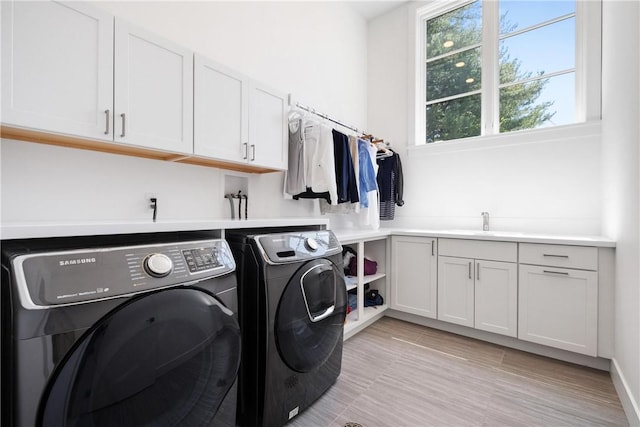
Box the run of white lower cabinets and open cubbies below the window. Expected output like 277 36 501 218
350 235 614 358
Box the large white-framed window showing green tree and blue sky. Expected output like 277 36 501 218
416 0 600 144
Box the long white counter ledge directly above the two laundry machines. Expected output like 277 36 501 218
0 218 329 240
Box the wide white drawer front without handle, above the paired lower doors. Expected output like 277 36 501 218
438 239 518 262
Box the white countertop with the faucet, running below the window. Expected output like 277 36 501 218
333 228 616 247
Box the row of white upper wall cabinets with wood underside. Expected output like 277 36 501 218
0 0 288 172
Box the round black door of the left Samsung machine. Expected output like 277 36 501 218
38 288 240 427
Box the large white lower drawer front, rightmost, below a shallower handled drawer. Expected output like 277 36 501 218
518 264 598 356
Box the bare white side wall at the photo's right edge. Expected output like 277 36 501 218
602 0 640 425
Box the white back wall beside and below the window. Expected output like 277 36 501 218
368 4 602 234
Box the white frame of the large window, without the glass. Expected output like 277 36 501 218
409 0 602 149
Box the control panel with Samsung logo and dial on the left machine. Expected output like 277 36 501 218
12 239 236 309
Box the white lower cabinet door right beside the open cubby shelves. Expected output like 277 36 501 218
391 236 438 319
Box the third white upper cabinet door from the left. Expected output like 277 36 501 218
193 55 249 162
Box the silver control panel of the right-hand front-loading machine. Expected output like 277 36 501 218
255 230 342 264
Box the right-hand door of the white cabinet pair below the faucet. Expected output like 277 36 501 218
474 260 518 337
